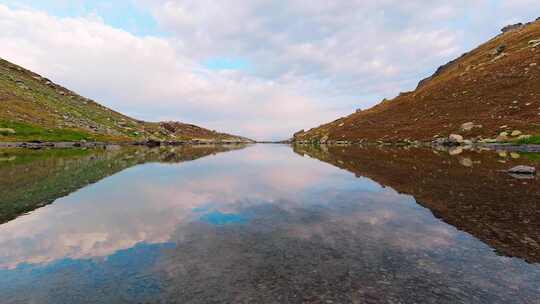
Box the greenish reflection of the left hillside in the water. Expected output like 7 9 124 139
0 145 245 223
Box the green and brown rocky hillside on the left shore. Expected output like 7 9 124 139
0 59 249 142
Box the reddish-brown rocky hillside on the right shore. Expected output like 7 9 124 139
294 20 540 143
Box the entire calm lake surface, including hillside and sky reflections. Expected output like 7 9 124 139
0 145 540 304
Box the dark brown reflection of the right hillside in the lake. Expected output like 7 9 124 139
294 146 540 263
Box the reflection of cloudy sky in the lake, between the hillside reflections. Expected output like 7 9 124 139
0 145 540 303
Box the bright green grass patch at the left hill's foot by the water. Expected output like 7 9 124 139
0 121 95 142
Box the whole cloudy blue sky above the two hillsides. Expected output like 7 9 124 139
0 0 540 140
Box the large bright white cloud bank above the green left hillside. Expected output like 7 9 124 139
0 6 346 138
